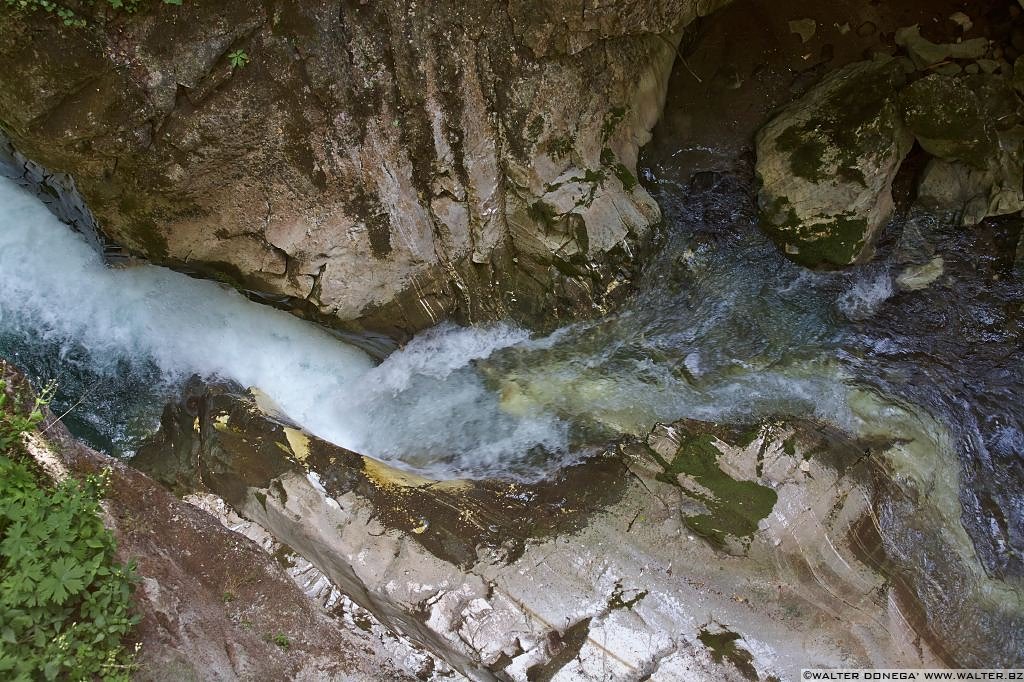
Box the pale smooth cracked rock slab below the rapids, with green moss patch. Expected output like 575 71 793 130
136 385 1018 680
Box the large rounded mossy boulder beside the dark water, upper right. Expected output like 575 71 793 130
756 58 912 267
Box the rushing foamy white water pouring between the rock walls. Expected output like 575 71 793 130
0 179 567 475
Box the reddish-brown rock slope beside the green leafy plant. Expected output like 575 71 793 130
0 360 432 682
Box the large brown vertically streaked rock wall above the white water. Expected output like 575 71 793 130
0 0 726 337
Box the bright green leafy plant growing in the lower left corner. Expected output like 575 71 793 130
0 380 137 680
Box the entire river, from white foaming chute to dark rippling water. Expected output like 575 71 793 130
0 139 1024 663
